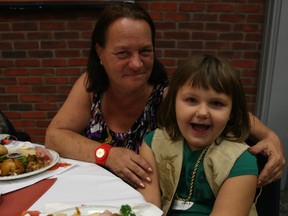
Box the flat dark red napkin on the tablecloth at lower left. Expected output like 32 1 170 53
0 178 57 216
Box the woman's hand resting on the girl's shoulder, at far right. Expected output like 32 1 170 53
249 133 285 187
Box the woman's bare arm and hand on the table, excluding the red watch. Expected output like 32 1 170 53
45 73 151 187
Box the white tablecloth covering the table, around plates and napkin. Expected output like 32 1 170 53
0 141 162 216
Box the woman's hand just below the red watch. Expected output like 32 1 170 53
105 147 152 188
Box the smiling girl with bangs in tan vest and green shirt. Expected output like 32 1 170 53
139 55 258 216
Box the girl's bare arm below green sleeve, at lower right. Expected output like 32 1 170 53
211 175 257 216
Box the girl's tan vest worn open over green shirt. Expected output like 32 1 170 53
151 129 257 216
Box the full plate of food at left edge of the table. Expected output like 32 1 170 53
0 145 60 181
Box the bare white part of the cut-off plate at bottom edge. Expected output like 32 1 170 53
53 205 120 216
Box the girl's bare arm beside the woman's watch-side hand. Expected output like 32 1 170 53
138 141 161 208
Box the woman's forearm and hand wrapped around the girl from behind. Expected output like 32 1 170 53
249 114 285 186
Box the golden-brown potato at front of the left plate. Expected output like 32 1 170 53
1 158 25 176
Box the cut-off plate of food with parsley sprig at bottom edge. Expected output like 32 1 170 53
52 205 136 216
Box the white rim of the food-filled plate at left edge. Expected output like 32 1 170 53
0 149 60 181
